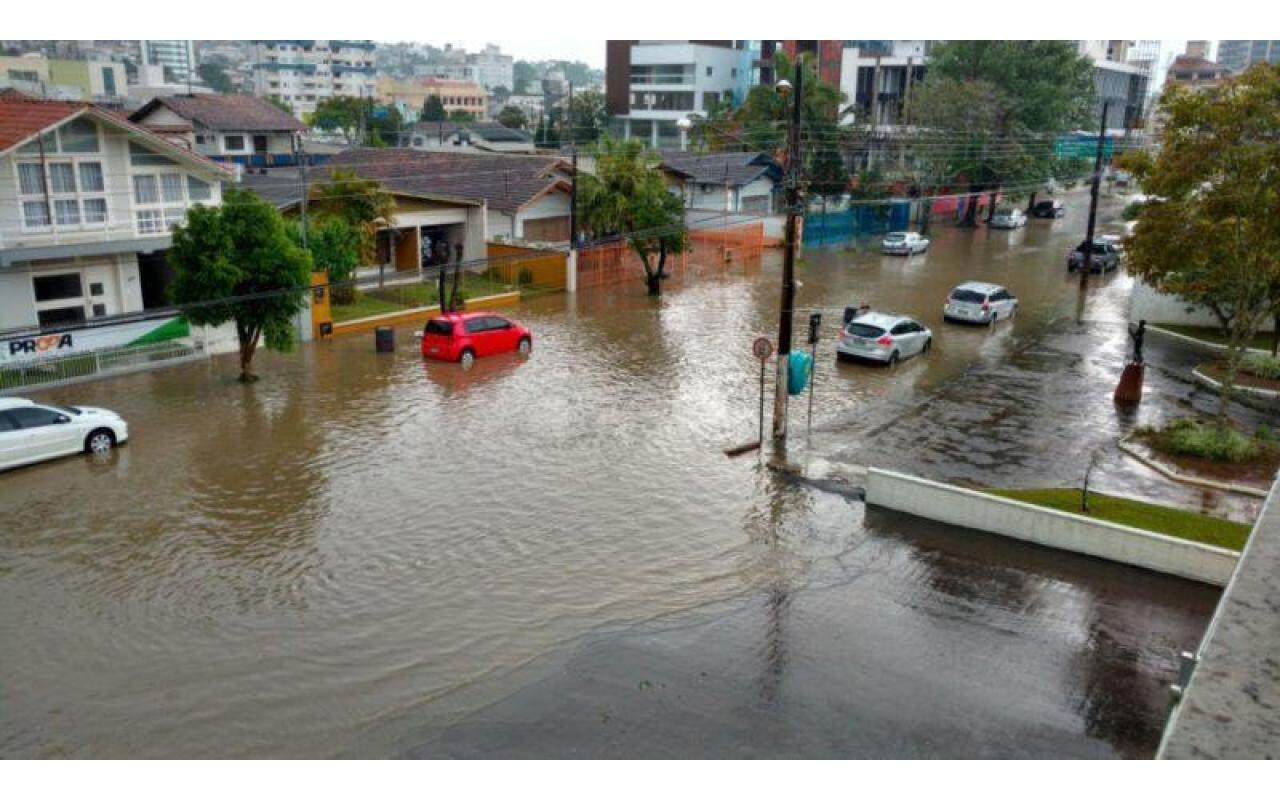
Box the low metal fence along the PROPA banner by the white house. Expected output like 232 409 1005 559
0 340 205 394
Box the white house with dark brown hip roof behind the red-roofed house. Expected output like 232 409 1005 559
129 93 307 166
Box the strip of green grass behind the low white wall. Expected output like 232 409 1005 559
987 489 1251 550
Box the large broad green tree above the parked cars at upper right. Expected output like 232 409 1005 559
911 40 1094 227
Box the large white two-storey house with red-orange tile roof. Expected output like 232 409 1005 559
0 91 234 350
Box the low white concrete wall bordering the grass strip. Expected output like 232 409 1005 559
867 468 1239 586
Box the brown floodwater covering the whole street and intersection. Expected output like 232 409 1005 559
0 193 1218 758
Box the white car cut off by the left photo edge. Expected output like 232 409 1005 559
0 397 129 470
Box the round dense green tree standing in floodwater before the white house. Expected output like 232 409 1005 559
168 187 311 383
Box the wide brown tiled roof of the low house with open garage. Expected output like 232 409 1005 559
329 147 571 214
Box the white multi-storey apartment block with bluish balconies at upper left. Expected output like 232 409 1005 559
253 38 376 119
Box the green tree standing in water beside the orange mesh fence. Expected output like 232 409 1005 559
577 137 689 296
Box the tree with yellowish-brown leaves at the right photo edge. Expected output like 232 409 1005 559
1123 64 1280 429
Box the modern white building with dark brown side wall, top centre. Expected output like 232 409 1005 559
604 40 754 147
